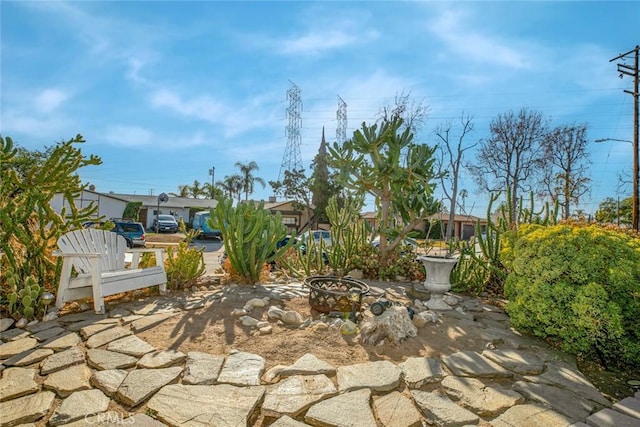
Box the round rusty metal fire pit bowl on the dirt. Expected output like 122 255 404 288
304 276 369 314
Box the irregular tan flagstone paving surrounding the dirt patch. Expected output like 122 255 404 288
0 282 640 427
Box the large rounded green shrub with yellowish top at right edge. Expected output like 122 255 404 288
504 224 640 366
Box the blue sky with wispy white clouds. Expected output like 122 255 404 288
0 0 640 216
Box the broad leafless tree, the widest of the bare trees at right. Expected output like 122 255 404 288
467 108 548 224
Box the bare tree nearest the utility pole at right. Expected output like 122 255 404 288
541 124 591 219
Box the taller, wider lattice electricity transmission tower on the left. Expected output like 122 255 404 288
278 80 302 181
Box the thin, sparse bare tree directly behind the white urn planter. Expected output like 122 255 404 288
436 114 478 240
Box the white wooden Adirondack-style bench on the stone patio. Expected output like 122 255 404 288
54 228 167 314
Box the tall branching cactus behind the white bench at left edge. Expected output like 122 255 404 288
0 135 101 298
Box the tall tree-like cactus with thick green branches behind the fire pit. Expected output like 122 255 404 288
329 115 439 265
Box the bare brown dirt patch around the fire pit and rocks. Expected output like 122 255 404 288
139 286 484 369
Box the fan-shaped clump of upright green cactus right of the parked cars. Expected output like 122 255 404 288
208 199 294 284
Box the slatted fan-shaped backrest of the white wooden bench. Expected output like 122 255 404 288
58 228 127 273
